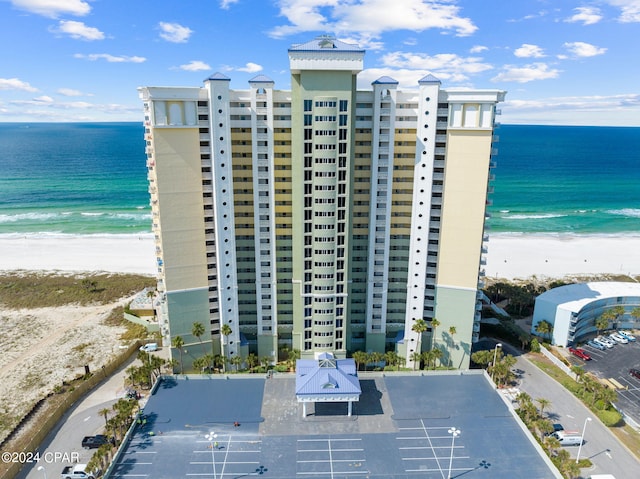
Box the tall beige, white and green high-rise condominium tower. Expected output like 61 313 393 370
140 36 505 367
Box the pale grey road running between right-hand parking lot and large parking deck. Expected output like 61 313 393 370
504 345 640 479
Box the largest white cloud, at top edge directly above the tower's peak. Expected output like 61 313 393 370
271 0 478 37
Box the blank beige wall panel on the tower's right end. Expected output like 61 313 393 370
438 130 492 289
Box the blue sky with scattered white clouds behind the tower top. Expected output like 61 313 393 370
0 0 640 126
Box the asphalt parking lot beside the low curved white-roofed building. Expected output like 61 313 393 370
569 335 640 424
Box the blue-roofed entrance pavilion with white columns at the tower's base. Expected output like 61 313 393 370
296 353 362 417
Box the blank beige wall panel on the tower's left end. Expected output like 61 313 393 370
153 128 207 291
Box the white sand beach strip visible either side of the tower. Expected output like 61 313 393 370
0 233 640 279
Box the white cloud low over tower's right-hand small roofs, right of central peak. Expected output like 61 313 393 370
382 52 493 82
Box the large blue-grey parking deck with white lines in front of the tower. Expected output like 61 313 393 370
109 372 554 479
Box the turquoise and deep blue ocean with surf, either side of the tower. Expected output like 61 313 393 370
0 123 640 237
